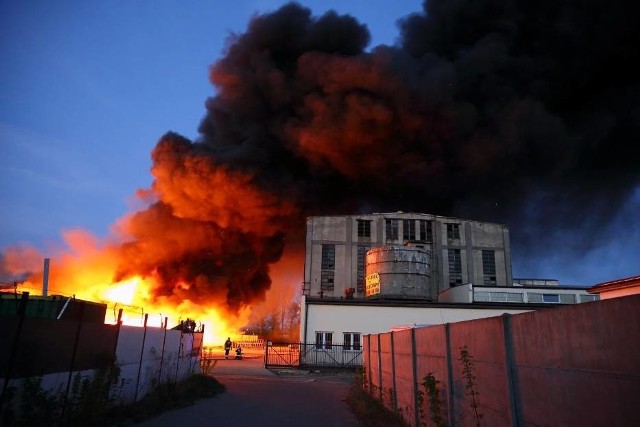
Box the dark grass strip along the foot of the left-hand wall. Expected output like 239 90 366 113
107 374 225 426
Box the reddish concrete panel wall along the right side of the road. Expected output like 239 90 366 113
363 296 640 426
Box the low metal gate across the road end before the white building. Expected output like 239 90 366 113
264 342 362 368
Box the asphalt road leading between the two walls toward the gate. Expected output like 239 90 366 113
139 355 361 427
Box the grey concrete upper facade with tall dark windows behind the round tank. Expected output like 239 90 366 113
303 212 513 299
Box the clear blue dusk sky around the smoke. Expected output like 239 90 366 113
0 0 640 285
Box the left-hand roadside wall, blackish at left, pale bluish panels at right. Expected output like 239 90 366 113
0 317 203 416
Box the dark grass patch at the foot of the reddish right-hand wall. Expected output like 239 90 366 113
346 375 407 427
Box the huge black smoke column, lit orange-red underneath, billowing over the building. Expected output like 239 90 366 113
2 0 640 310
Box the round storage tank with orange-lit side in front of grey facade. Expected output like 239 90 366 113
365 246 437 301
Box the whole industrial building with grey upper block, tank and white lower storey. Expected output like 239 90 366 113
300 212 598 363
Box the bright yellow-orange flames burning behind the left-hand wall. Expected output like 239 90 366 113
7 230 250 346
